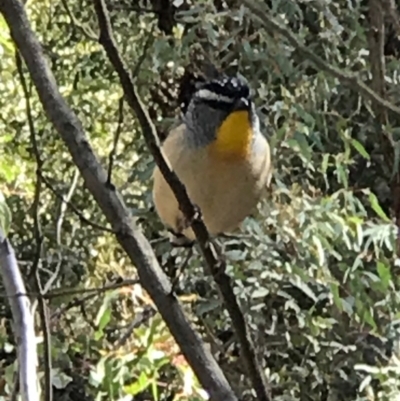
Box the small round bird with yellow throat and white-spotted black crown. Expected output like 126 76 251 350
153 71 272 243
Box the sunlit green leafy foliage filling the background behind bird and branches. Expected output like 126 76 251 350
0 0 400 401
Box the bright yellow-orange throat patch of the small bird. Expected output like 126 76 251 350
209 110 253 160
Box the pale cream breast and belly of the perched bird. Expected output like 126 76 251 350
153 125 271 239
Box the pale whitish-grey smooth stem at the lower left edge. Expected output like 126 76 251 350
0 229 39 401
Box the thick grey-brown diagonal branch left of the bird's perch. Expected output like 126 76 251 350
0 0 237 401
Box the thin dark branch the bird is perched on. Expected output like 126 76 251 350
94 0 270 401
